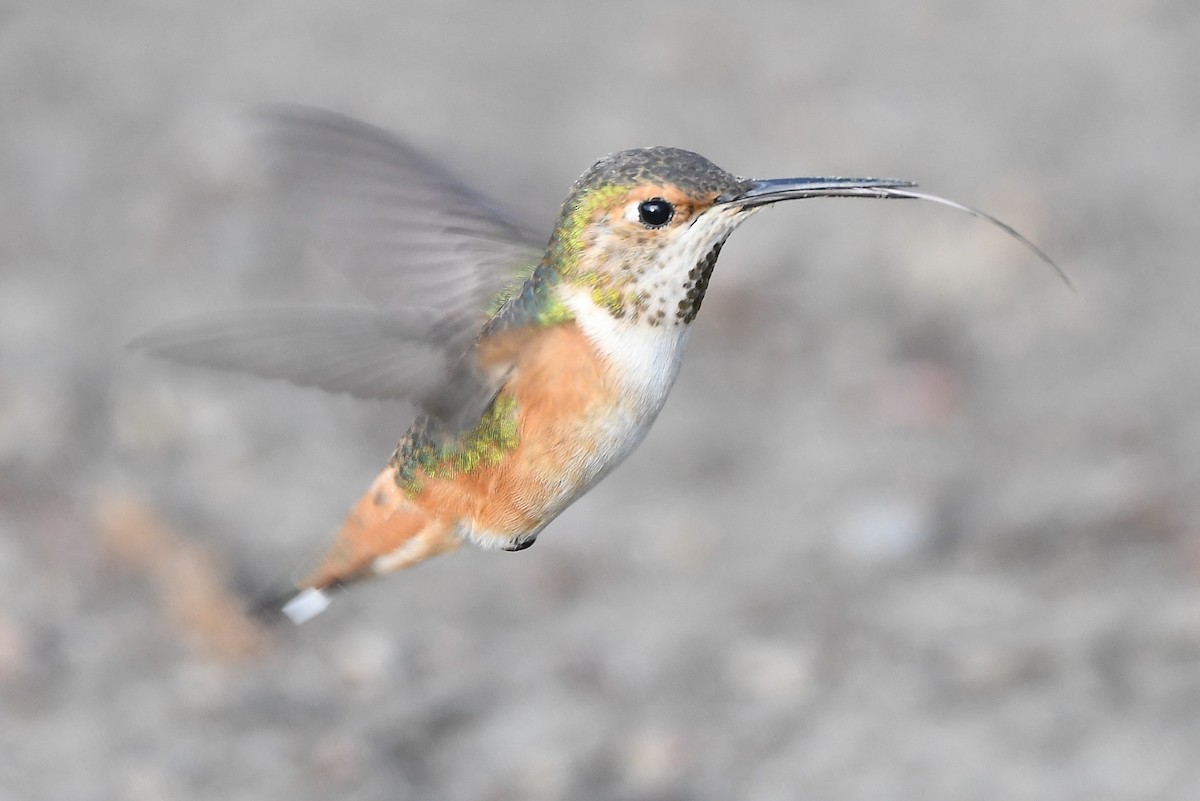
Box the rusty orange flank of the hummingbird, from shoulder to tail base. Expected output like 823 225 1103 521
300 323 618 589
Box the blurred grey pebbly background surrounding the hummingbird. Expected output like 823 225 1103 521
0 0 1200 801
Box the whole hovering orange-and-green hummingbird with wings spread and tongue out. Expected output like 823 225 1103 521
133 108 1066 622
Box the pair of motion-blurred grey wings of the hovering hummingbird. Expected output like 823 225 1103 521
131 107 545 435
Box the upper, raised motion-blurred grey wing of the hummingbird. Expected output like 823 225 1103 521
263 107 546 345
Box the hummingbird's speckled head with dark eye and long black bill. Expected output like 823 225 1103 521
546 147 912 326
